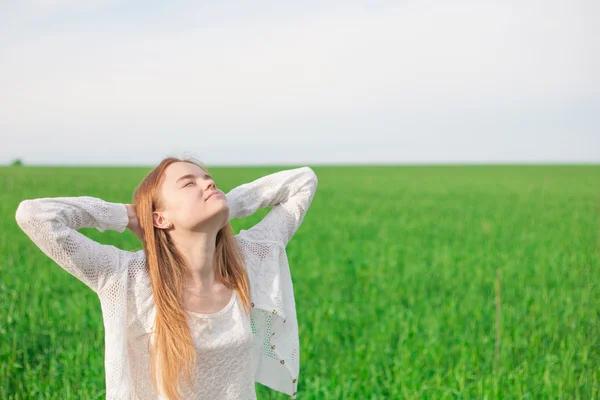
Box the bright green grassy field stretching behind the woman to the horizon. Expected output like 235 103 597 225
0 166 600 399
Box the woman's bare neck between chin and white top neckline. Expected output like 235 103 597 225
171 230 217 291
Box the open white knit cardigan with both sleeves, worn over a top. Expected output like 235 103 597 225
16 167 318 400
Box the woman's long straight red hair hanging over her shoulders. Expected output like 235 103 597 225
133 157 251 400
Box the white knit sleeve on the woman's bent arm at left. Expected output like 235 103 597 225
16 196 129 293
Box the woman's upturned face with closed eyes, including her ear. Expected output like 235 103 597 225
153 162 229 230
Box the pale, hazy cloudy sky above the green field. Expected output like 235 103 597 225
0 0 600 166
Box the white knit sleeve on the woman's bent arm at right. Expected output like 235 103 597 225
226 167 318 247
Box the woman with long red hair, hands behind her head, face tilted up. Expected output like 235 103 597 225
16 157 318 400
